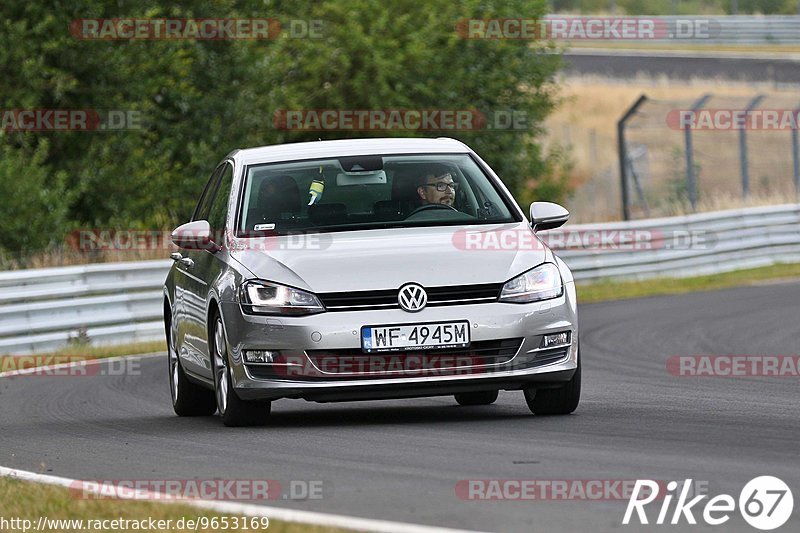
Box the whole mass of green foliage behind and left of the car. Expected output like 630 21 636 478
0 0 566 258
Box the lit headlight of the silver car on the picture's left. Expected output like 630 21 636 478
241 281 325 315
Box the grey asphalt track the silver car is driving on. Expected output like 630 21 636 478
0 283 800 532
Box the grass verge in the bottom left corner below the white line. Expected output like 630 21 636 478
0 478 347 533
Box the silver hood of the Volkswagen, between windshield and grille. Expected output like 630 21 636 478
231 222 548 292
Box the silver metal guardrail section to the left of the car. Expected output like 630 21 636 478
0 260 172 354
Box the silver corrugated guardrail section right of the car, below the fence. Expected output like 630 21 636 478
547 204 800 281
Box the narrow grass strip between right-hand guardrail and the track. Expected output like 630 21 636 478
577 263 800 303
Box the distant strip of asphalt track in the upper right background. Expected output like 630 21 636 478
564 49 800 85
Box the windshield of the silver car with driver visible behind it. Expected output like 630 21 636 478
238 154 516 237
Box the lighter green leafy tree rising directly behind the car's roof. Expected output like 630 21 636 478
259 0 564 204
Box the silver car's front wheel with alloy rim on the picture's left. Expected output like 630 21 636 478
209 314 272 427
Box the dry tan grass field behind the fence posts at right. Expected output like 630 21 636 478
546 77 800 222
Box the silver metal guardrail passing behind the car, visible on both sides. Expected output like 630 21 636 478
0 204 800 354
